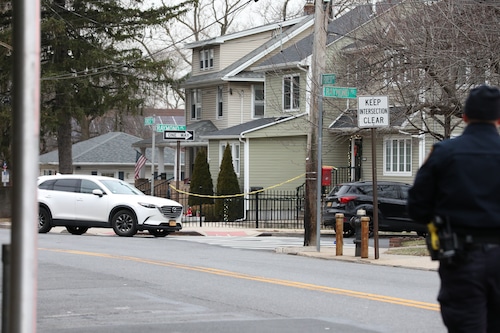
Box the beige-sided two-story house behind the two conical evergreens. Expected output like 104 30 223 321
184 15 314 191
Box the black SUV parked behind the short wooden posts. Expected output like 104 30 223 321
323 181 427 237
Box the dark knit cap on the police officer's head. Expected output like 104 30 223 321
464 85 500 121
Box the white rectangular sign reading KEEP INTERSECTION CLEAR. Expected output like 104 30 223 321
358 96 389 128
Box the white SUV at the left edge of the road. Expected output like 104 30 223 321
38 175 182 237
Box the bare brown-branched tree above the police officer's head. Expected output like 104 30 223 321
340 0 500 140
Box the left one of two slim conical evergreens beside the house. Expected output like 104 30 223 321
188 149 214 206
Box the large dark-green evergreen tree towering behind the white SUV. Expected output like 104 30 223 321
19 0 188 173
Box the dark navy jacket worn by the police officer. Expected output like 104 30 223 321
408 123 500 231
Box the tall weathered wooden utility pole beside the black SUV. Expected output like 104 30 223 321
304 0 330 246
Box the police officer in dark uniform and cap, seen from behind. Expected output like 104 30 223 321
408 85 500 333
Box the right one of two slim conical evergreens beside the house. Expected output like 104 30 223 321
215 144 243 221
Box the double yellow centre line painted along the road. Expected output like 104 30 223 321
39 248 440 311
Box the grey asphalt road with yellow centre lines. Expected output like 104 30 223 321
0 230 445 333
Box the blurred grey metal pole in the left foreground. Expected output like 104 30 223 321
10 0 41 333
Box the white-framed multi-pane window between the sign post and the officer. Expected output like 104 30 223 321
384 138 412 176
